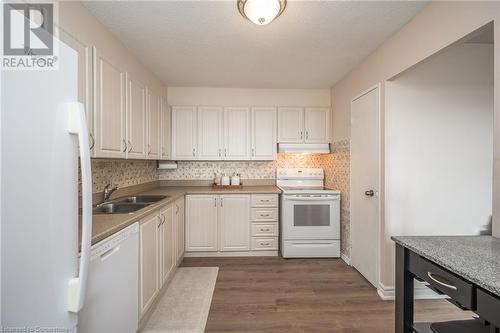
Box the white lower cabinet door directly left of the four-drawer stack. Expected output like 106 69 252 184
219 194 250 251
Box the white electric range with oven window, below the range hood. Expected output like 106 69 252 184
276 168 340 258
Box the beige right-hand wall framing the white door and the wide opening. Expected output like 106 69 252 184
332 2 500 287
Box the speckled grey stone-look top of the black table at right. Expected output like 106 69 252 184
392 236 500 296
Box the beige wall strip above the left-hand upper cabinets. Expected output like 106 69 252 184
58 1 165 92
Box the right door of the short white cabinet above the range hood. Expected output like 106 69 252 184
304 108 331 143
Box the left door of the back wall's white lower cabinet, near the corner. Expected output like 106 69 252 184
186 195 219 251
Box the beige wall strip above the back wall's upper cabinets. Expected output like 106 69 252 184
168 87 331 107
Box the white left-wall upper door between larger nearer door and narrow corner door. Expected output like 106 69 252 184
127 74 146 159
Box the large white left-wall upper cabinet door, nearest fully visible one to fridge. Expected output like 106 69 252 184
94 48 127 158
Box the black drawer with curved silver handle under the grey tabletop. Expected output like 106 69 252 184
408 252 476 310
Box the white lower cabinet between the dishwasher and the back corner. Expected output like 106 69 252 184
139 197 184 320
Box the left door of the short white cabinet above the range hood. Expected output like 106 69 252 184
278 107 304 143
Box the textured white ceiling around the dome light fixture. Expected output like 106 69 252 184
85 0 427 88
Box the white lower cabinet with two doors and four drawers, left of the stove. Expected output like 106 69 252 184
186 194 279 257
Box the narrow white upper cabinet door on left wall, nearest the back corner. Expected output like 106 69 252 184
146 90 161 160
